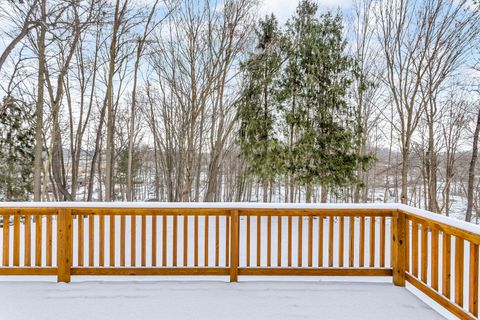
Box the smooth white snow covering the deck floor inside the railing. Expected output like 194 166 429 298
0 280 445 320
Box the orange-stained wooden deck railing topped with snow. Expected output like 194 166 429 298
0 203 480 319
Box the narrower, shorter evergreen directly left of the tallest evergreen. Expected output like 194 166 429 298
238 15 281 201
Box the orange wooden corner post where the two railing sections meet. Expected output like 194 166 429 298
392 210 407 287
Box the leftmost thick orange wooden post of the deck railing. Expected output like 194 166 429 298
57 208 72 282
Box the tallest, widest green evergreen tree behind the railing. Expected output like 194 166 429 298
281 0 368 201
